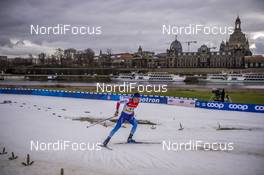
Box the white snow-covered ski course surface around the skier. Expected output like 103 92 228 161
0 94 264 175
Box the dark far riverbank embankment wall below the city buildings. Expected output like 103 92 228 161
6 66 264 75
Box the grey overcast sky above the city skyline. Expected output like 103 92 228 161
0 0 264 57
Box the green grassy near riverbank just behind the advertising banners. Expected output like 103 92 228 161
0 85 264 104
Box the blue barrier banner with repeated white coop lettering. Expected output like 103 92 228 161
195 100 264 113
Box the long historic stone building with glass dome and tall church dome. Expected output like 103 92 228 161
167 17 252 68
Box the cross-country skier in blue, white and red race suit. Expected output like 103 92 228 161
103 93 140 146
